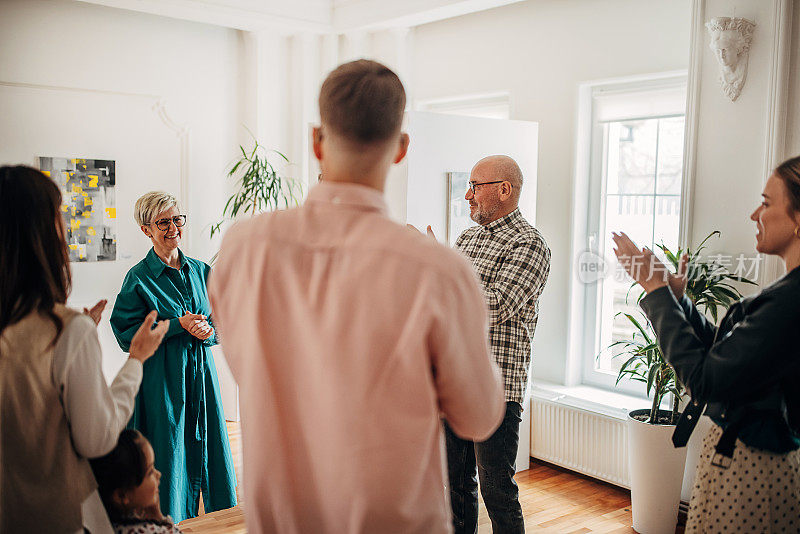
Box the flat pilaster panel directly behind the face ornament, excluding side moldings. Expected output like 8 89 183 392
691 0 774 268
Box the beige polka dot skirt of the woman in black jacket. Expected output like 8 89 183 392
686 425 800 534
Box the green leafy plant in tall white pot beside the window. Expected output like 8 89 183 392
609 232 755 534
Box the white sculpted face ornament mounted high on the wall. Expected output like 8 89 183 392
706 17 756 102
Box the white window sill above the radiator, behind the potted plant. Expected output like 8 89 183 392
531 380 650 421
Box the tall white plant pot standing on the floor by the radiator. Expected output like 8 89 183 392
628 409 686 534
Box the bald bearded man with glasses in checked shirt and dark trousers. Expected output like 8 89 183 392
445 156 550 534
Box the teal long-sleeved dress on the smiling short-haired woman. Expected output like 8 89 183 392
111 249 236 522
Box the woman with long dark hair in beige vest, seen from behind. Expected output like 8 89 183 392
0 166 169 533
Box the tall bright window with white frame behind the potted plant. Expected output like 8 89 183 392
573 75 686 395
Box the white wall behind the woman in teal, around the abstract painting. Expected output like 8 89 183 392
0 0 246 404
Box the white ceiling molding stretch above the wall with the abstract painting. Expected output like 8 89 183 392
78 0 332 34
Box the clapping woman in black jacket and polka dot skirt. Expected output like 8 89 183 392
613 157 800 533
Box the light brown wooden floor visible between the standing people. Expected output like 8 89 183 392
180 422 635 534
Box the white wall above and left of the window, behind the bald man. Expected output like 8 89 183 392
409 0 690 383
